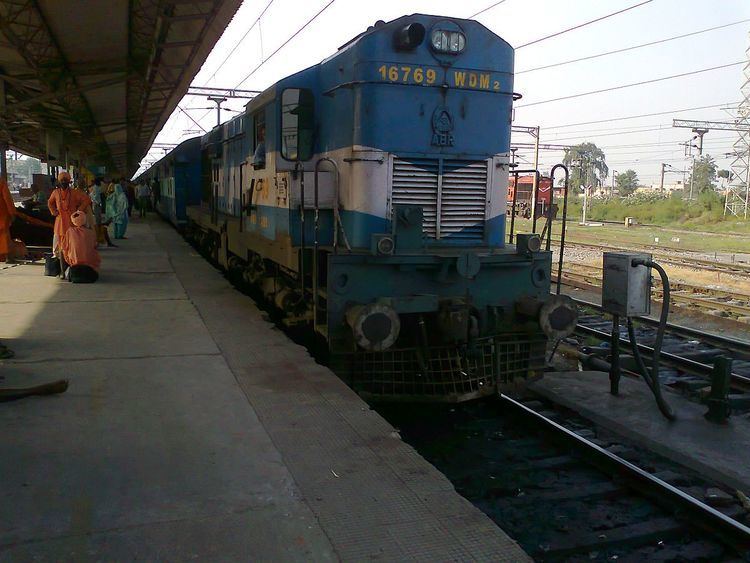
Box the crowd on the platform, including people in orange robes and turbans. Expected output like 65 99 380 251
0 171 152 283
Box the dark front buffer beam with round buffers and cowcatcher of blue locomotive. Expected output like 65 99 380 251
326 240 575 402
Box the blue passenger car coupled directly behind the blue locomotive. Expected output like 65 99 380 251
136 137 201 228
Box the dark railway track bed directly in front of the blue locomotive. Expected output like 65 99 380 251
383 396 750 561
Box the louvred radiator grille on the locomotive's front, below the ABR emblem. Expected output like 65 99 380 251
391 157 487 241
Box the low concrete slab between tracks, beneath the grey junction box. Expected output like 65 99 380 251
530 371 750 493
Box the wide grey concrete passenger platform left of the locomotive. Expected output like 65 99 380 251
0 220 528 561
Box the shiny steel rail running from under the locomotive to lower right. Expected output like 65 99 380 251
500 394 750 555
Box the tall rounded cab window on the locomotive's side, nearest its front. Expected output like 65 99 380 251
281 88 315 160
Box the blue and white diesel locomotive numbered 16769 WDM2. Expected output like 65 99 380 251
140 14 575 401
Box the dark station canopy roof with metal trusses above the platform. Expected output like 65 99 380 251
0 0 241 177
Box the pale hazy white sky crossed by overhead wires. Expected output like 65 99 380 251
137 0 750 185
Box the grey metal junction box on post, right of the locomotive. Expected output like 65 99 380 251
602 252 651 317
